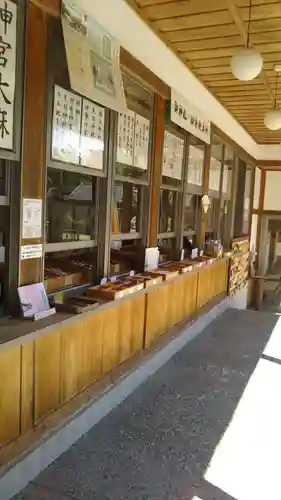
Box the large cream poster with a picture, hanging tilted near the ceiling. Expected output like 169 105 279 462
61 0 126 112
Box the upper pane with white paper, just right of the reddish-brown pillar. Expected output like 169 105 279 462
162 130 184 185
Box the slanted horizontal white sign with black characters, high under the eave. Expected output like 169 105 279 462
171 89 211 144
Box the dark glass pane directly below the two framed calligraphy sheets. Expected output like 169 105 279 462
46 168 97 243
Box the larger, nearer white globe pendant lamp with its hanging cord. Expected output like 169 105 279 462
230 0 263 82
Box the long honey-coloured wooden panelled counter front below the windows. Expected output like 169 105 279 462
0 259 228 458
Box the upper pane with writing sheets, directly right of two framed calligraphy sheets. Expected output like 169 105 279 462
116 75 152 180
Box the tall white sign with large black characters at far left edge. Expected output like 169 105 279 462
0 0 17 150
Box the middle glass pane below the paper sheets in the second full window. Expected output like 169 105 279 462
112 181 141 233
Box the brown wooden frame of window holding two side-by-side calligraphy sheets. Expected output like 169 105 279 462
43 19 110 282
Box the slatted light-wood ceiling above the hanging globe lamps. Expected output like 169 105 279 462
127 0 281 144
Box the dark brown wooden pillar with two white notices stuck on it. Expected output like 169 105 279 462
20 2 48 285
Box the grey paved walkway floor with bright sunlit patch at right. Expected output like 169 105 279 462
14 310 281 500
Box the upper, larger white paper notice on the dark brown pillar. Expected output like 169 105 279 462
22 198 42 240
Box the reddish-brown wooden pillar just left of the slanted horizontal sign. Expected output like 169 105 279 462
148 94 165 247
